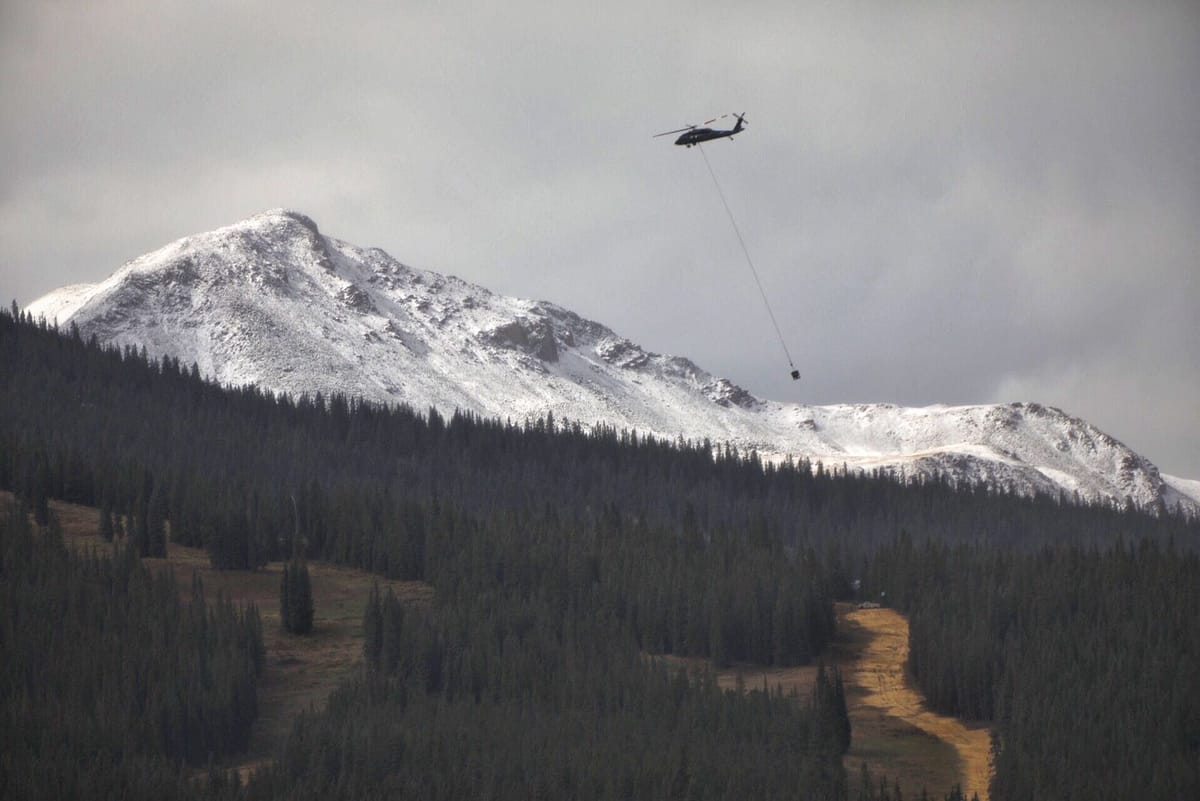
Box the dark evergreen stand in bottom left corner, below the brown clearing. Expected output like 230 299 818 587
0 507 263 800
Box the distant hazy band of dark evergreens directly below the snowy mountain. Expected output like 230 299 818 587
0 303 1198 578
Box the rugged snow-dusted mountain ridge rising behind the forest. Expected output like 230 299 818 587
26 210 1200 512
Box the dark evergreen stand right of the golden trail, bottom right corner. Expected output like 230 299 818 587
869 537 1200 801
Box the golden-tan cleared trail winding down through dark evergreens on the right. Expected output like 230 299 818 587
842 609 991 801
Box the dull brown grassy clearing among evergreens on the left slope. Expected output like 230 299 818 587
21 493 433 775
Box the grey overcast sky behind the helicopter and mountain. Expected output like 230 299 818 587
0 0 1200 478
